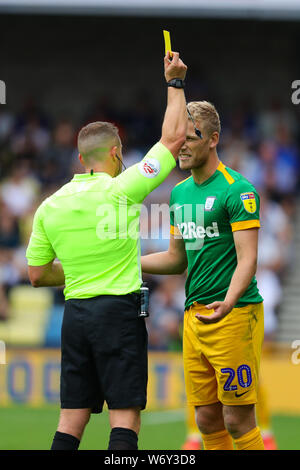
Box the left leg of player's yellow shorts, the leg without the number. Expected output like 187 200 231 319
183 309 218 406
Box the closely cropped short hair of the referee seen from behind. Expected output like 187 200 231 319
77 121 121 160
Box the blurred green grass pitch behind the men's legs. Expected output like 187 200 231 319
0 405 300 450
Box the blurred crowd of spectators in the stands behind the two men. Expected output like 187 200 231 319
0 93 300 350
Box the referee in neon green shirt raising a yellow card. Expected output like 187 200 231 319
26 52 187 450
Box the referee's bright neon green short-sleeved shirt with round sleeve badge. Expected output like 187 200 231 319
26 142 176 300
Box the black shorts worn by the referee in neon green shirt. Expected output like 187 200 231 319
60 293 148 413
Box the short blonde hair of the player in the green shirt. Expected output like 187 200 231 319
187 101 221 135
